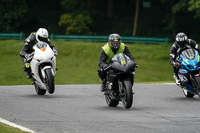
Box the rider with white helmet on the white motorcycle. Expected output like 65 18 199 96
20 28 58 79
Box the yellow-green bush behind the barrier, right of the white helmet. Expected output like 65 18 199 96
59 13 92 35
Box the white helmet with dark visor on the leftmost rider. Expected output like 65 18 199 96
36 28 49 42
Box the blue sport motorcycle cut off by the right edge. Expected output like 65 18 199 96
178 49 200 98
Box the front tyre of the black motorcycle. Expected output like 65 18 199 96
122 80 133 109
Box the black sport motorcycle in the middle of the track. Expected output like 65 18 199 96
104 53 138 109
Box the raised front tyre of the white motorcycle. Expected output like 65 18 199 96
45 69 55 94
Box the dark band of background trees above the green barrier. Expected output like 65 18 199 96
0 0 200 39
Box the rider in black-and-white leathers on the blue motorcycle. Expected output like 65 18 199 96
170 32 200 87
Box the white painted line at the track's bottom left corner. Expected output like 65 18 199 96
0 118 36 133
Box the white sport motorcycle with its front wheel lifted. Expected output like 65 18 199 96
28 43 56 95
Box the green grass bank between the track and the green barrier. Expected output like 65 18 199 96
0 40 173 85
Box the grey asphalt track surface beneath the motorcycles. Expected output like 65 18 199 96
0 84 200 133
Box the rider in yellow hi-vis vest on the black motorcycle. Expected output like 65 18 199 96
97 33 134 92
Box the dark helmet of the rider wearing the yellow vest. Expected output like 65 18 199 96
108 34 121 50
